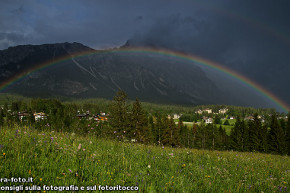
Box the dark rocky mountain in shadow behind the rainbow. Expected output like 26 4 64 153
0 43 265 106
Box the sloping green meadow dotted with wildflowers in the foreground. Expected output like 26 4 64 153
0 128 290 192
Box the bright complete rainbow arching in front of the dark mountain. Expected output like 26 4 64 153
0 47 290 112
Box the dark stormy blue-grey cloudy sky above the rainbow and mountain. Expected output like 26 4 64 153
0 0 290 108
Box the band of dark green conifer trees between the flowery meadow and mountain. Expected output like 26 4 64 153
0 90 290 155
